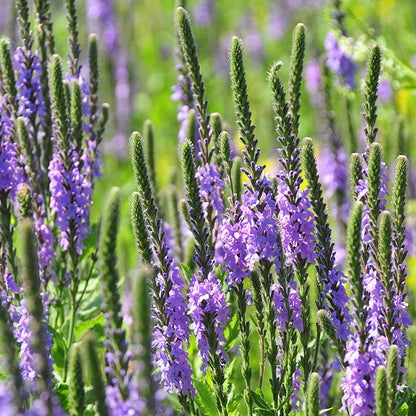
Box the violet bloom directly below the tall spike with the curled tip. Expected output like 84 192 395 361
277 181 315 265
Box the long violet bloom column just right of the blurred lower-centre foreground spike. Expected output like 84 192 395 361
152 259 195 396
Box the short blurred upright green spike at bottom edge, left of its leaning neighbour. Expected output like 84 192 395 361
69 344 85 416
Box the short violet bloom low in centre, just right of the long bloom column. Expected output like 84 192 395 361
188 271 229 373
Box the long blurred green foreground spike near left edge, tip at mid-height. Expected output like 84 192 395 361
18 218 56 414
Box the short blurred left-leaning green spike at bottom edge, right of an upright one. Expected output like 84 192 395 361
82 333 109 416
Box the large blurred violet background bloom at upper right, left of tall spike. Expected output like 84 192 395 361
325 31 358 89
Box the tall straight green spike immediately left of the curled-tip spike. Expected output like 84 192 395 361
229 37 262 189
